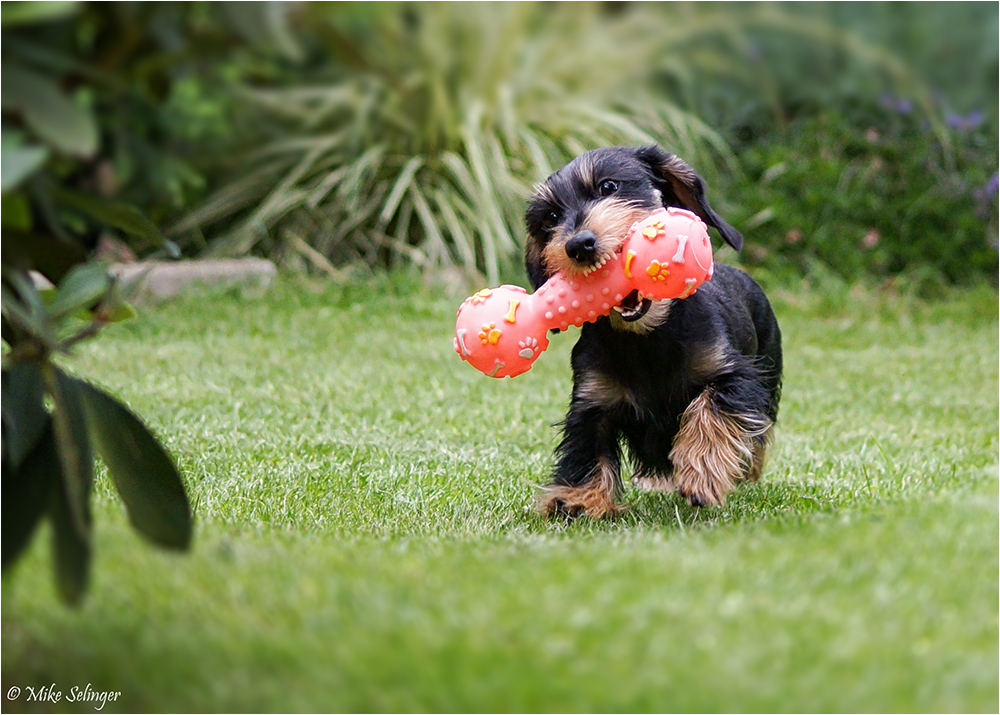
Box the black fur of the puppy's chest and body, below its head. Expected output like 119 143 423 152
554 264 781 485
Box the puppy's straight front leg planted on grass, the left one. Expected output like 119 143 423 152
538 398 621 519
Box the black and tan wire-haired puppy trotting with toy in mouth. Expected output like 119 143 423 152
525 146 782 518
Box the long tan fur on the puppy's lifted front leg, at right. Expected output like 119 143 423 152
670 388 771 506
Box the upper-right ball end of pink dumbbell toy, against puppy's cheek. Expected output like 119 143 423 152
624 207 714 300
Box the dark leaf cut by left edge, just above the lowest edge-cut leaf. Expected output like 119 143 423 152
0 360 49 474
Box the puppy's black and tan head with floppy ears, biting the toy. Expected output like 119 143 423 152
525 146 743 330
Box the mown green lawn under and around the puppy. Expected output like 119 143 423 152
3 272 998 712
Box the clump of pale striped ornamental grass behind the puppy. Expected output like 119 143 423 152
173 4 730 281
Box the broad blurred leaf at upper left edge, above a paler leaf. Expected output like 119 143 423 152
0 60 99 157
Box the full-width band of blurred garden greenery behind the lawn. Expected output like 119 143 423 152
4 2 997 290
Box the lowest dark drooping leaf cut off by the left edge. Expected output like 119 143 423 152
2 416 59 571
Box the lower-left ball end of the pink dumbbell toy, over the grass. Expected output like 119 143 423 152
453 286 549 377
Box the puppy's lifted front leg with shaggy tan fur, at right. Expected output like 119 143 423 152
670 372 772 506
